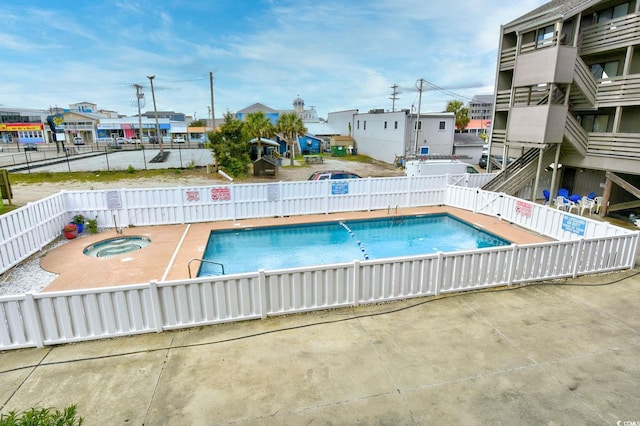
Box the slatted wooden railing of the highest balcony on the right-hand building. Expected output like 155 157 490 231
578 13 640 55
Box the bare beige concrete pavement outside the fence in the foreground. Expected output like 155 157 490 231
0 269 640 426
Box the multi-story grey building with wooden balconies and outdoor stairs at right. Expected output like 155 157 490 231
488 0 640 216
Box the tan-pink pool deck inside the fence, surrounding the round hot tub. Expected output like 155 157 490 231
40 207 549 291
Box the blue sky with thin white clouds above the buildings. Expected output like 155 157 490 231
0 0 546 118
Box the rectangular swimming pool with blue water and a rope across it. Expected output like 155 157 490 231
198 214 510 276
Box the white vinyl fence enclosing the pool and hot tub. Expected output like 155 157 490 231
0 175 639 350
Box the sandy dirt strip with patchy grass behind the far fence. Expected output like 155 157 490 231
11 157 404 206
